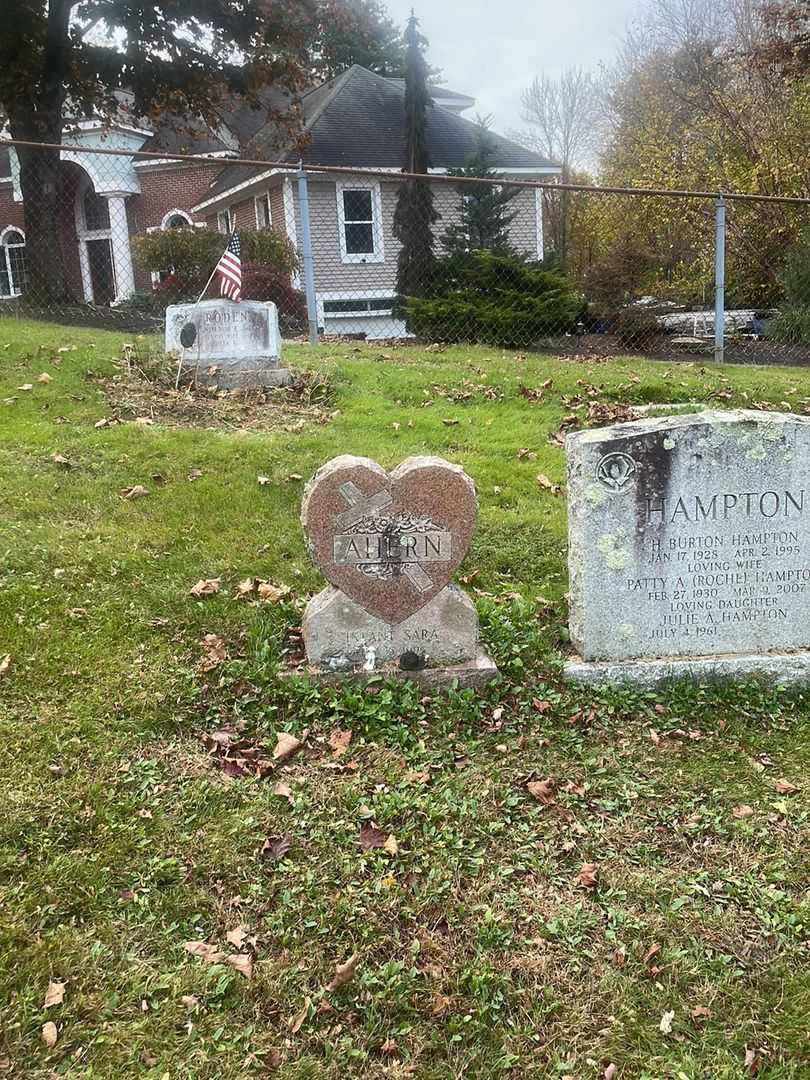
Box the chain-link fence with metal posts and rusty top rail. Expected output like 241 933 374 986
0 137 810 364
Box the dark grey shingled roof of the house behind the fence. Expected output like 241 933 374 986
201 64 558 199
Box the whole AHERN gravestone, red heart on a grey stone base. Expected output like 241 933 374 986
294 455 497 686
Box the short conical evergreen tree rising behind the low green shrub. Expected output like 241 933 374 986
442 118 517 256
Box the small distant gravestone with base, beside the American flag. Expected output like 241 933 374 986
165 299 292 390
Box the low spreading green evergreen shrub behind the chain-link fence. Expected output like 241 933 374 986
405 251 582 347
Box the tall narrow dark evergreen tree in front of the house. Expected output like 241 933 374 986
393 14 437 304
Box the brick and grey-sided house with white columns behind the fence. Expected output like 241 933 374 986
0 65 561 337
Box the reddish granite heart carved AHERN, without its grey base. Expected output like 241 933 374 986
301 455 478 624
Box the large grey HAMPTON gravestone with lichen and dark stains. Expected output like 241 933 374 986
566 411 810 686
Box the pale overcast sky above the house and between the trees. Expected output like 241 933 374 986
386 0 640 133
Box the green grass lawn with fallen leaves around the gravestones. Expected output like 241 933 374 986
0 320 810 1080
